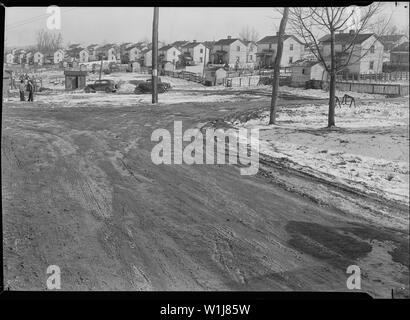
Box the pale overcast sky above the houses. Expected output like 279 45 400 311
5 2 409 47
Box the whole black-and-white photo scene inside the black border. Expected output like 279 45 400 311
1 2 410 302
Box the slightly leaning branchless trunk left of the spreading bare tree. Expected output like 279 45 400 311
269 7 289 124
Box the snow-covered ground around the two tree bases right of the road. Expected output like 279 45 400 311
233 101 409 204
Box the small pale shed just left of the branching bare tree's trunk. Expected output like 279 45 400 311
290 60 327 87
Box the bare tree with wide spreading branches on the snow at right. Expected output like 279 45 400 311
289 2 381 127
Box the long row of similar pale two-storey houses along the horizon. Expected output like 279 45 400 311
5 31 408 74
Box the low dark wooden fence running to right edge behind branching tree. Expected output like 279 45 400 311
336 81 409 96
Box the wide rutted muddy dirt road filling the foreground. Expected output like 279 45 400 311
2 95 409 297
